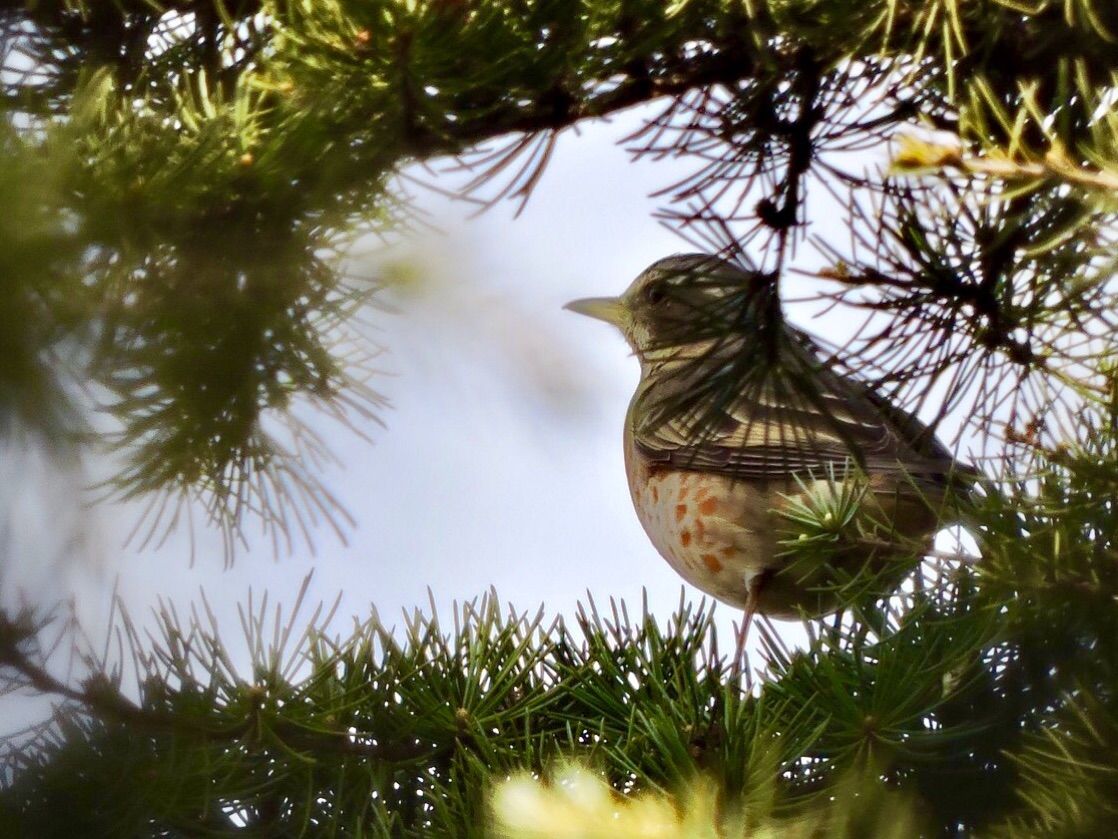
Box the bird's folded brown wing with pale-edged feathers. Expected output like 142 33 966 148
632 335 954 480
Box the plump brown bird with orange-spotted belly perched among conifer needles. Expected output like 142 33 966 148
566 254 964 625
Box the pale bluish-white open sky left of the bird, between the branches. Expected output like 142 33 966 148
0 105 903 698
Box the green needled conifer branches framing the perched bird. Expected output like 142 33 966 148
0 0 1118 837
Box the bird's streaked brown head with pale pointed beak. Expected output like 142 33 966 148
565 254 760 361
